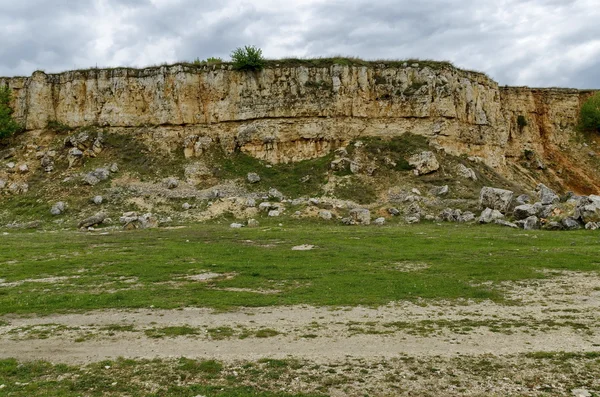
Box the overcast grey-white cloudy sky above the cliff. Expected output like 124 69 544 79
0 0 600 88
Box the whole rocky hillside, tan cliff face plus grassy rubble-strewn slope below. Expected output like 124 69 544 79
0 59 600 229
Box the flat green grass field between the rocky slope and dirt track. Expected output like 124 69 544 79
0 221 600 315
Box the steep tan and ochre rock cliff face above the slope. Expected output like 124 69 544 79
0 64 590 189
